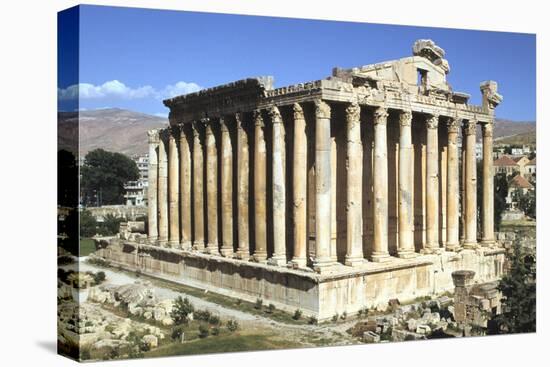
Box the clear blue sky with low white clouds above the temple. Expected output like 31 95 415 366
58 6 536 120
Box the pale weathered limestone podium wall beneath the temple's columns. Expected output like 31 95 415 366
96 244 504 320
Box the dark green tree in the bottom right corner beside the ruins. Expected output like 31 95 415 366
489 241 537 334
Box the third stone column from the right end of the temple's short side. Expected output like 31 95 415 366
445 118 460 251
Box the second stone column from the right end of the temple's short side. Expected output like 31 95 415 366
463 120 477 248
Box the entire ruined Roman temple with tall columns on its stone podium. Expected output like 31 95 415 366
99 40 504 320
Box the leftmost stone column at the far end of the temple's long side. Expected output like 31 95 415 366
147 130 159 244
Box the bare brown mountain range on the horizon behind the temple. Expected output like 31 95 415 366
58 108 536 156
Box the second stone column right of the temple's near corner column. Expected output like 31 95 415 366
372 107 390 262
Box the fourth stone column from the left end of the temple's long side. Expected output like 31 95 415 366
179 124 192 250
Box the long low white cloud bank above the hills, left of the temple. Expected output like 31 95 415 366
57 80 202 100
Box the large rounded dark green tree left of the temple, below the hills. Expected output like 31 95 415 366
81 149 139 205
